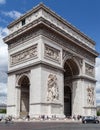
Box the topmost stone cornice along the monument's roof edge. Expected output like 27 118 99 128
8 4 95 45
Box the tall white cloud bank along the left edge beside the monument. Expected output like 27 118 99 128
0 27 8 103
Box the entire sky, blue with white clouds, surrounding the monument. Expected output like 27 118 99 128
0 0 100 104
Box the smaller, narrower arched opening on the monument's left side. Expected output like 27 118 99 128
19 75 30 116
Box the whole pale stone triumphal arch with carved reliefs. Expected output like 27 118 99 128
4 4 98 117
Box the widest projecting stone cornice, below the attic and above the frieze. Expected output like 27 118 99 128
4 17 98 57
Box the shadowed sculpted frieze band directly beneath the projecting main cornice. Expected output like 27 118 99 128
6 19 95 63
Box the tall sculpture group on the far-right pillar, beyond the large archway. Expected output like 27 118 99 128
87 86 94 106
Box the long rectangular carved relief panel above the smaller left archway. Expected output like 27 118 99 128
10 45 37 65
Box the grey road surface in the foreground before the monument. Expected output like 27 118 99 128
0 121 100 130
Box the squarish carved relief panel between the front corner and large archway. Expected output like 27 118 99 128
44 44 60 63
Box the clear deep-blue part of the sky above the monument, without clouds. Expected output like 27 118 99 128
0 0 100 52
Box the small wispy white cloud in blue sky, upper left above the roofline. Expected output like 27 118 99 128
2 10 22 19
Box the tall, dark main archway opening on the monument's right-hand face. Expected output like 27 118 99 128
64 59 79 116
